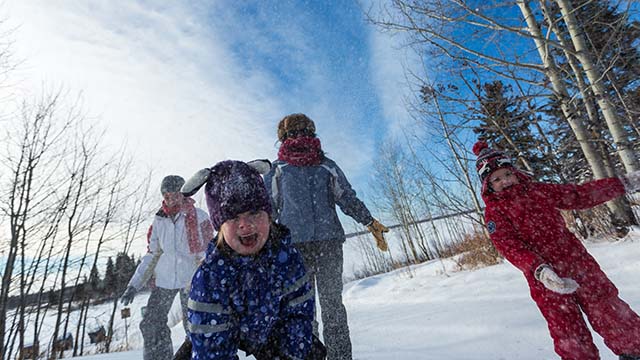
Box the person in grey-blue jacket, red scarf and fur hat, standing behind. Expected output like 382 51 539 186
265 114 388 360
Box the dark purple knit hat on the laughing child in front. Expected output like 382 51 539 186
205 160 271 230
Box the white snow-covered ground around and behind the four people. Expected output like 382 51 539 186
38 230 640 360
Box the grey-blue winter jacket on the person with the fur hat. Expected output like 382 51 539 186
265 157 373 243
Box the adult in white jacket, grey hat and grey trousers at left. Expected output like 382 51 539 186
121 175 213 360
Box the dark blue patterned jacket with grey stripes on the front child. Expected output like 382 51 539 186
188 224 315 360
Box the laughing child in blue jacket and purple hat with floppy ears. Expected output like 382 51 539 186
183 160 324 360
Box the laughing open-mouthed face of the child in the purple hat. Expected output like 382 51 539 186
220 210 271 255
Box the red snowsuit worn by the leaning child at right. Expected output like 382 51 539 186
482 170 640 360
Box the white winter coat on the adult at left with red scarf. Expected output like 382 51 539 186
129 208 213 289
